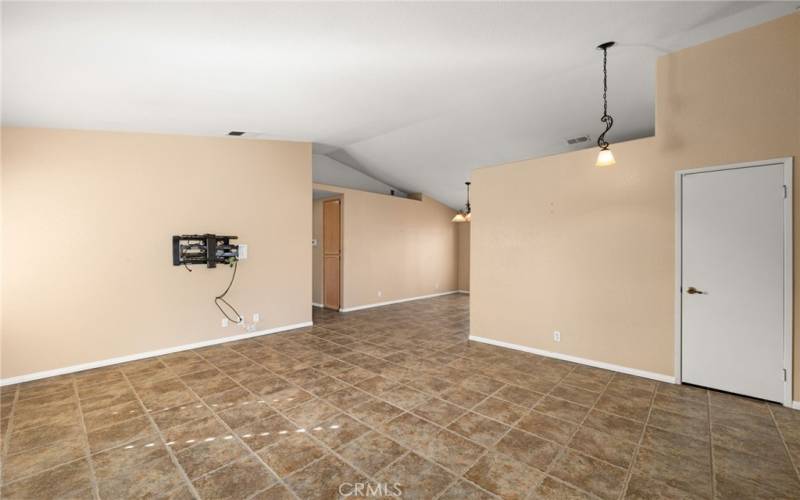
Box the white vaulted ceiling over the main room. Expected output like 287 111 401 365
2 2 798 207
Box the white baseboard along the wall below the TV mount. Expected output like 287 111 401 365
0 321 313 386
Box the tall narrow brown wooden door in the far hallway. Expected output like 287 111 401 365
322 200 342 310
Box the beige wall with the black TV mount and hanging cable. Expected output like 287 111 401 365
2 128 311 378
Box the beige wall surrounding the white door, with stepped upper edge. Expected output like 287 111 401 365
471 14 800 399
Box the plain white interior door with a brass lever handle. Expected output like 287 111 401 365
681 163 786 402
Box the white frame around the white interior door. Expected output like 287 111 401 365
674 157 794 407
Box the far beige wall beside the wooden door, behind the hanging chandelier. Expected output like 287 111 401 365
314 184 458 309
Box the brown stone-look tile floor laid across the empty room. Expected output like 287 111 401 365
0 295 800 499
